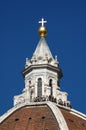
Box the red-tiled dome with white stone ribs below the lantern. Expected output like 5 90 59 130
0 101 86 130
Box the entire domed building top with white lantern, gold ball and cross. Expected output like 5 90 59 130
0 19 86 130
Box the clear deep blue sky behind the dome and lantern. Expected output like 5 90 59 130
0 0 86 115
